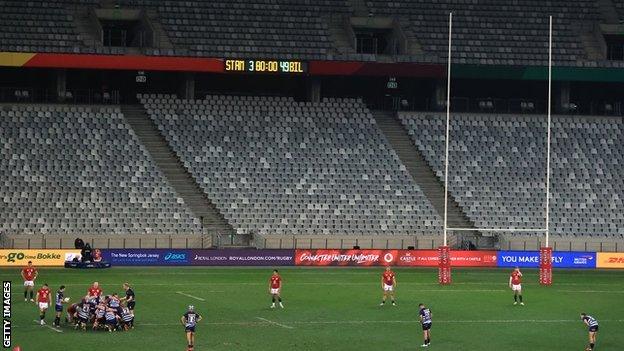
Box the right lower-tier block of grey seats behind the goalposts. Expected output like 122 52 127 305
400 112 624 237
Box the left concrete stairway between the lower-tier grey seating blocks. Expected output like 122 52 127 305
121 105 234 234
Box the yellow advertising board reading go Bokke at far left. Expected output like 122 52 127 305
0 249 80 267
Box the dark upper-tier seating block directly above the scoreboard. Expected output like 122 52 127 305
149 0 350 59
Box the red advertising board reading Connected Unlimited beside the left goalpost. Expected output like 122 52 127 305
295 250 497 267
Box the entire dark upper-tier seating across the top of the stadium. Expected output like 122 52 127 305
0 0 624 67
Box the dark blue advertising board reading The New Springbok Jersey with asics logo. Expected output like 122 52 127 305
102 249 191 266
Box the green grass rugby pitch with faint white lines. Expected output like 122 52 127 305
0 268 624 351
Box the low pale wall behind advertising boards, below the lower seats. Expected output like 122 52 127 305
0 234 624 252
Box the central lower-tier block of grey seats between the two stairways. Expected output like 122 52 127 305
139 94 441 235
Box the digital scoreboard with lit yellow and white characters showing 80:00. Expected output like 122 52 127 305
224 59 308 74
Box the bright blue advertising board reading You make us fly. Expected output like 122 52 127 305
497 251 596 268
